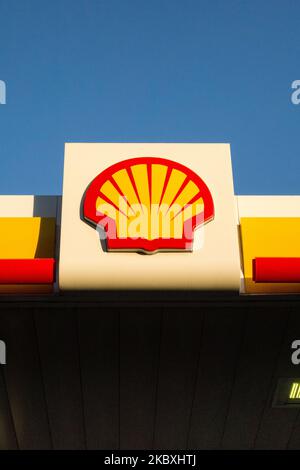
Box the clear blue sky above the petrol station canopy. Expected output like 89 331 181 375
0 0 300 194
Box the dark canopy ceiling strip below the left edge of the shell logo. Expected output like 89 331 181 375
78 303 119 449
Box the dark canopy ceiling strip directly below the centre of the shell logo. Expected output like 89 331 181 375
120 304 162 449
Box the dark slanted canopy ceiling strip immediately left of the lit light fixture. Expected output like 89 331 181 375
222 302 287 449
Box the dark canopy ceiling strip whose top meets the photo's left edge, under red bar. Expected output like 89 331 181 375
0 304 52 449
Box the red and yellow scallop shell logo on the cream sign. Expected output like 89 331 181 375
83 157 214 254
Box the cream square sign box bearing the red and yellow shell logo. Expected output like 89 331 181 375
59 143 240 291
